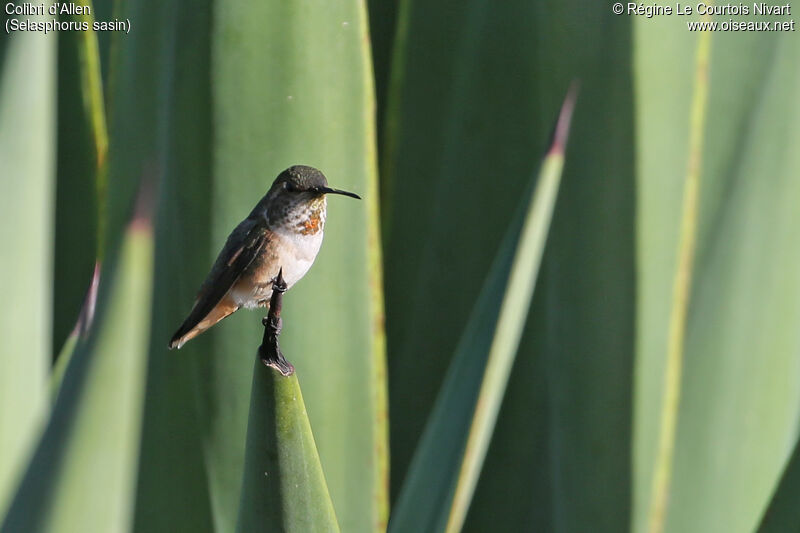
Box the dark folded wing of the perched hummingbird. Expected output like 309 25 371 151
170 218 268 347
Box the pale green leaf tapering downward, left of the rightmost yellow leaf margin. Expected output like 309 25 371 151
632 24 696 532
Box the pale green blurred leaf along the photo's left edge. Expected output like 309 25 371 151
0 26 57 518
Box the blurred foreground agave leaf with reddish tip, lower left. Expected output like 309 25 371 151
1 208 153 533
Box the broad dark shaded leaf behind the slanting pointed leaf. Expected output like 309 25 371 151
382 1 636 532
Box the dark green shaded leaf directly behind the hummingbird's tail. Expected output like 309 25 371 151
108 0 216 533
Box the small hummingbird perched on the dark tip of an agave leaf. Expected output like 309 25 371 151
169 165 361 349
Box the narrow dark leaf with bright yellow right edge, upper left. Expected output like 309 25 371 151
52 0 108 362
